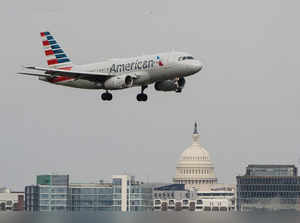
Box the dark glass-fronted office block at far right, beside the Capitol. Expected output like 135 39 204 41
237 165 300 210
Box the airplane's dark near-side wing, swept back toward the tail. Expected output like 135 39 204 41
19 66 114 81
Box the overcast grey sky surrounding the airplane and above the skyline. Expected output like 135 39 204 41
0 0 300 189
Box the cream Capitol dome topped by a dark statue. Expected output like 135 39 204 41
174 123 217 190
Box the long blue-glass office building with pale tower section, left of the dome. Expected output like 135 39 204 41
25 175 153 212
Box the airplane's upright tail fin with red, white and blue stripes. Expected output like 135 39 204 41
41 32 73 69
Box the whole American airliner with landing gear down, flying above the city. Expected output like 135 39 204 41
18 31 203 101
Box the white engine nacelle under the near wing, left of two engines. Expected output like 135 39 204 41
104 75 133 90
